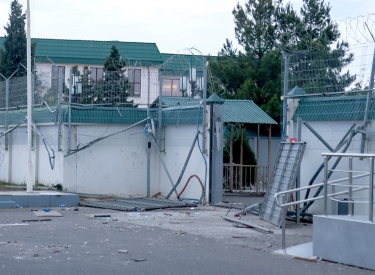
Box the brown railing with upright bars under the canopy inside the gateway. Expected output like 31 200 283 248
223 163 269 193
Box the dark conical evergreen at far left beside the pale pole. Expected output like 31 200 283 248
0 0 36 77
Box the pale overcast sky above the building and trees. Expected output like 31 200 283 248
0 0 375 55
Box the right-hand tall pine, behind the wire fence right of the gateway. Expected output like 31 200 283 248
280 0 356 93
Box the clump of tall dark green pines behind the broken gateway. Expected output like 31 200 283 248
210 0 355 121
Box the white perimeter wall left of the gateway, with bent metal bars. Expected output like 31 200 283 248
0 125 208 199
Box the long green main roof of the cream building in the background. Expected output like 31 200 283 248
0 37 163 66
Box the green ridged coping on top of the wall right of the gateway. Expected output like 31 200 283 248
293 95 375 121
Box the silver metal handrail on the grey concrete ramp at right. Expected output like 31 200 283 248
275 153 375 249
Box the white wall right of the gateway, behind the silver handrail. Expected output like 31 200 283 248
294 121 375 215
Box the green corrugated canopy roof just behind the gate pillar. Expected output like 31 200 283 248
153 96 277 124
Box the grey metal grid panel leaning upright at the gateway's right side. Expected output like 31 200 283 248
259 142 306 226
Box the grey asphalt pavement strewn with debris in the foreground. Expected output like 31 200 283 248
0 206 374 275
